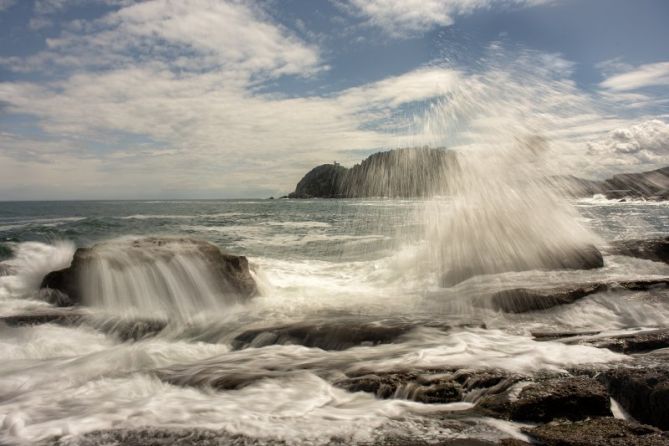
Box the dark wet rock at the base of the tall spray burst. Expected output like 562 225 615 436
441 245 604 287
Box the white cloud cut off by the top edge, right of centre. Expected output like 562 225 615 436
348 0 551 37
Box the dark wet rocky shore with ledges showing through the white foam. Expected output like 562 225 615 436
5 237 669 446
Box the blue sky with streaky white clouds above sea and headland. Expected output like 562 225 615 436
0 0 669 200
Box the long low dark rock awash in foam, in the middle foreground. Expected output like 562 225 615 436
232 320 414 350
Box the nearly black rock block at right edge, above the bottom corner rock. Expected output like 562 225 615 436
599 366 669 430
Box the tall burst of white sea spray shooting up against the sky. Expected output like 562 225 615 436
416 51 603 286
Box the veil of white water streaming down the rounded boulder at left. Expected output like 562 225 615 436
79 239 247 319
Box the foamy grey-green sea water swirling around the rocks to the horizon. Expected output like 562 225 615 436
0 197 669 444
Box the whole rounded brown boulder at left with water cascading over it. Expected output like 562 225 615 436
41 237 257 317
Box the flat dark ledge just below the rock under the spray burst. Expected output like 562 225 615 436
490 284 607 313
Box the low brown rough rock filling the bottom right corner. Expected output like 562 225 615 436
523 417 669 446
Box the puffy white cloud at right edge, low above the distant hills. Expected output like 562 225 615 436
588 119 669 165
